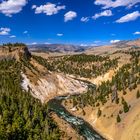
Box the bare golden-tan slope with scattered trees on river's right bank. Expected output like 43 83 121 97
62 86 140 140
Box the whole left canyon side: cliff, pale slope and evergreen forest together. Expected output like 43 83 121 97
0 44 87 140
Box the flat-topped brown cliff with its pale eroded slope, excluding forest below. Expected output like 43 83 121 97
0 46 88 103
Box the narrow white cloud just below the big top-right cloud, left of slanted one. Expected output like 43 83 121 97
92 10 113 19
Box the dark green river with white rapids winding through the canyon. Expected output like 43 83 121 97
48 97 105 140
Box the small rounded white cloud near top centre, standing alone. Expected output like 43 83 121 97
64 11 77 22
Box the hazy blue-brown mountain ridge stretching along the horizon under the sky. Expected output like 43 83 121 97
28 39 140 53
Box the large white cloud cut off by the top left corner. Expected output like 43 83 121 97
0 0 27 17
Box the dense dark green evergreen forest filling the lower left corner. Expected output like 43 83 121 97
0 59 61 140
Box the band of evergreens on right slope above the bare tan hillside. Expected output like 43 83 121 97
65 50 140 122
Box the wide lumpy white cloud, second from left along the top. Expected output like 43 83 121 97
32 3 66 16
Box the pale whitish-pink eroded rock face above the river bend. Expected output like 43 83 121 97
22 73 88 103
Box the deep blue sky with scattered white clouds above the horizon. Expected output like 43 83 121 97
0 0 140 45
